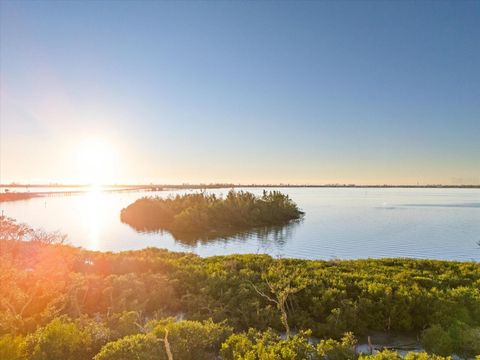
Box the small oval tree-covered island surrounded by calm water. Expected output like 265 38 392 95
120 190 303 239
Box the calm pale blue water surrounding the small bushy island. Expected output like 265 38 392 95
0 188 480 261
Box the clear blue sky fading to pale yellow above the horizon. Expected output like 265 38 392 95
0 0 480 185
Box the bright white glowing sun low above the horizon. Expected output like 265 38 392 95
77 136 116 186
